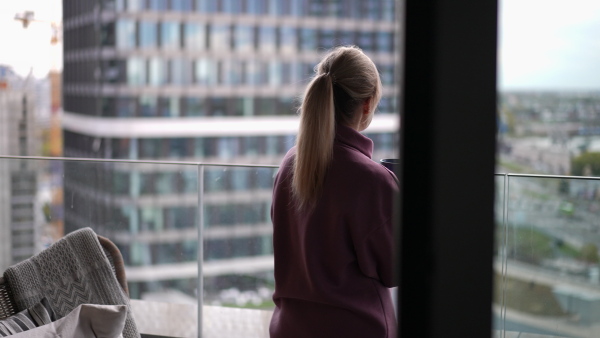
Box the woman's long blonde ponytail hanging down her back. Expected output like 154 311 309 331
292 73 335 209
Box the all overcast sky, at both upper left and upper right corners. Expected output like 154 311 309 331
0 0 600 90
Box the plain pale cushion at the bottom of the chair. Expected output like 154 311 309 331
12 304 127 338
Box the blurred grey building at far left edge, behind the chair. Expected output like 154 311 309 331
0 65 40 271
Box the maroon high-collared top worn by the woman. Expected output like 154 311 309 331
270 125 398 338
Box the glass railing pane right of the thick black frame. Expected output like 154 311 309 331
496 176 600 337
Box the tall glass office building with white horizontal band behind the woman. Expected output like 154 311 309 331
63 0 399 297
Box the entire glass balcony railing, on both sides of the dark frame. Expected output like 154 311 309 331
0 156 600 337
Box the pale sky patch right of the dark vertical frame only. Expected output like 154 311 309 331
498 0 600 90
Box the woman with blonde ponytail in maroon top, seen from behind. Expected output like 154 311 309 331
270 47 398 338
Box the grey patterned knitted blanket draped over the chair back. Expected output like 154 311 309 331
4 228 140 338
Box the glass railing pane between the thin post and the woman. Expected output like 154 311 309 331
202 166 277 320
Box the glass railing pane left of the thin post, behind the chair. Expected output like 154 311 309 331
0 158 199 304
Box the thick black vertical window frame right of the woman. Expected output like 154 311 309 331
398 0 497 337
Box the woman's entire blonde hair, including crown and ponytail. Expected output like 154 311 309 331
292 46 381 209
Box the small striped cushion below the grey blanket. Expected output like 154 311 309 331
0 298 56 337
